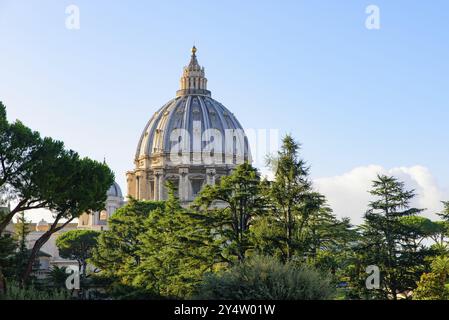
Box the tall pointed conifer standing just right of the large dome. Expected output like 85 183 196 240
252 135 357 288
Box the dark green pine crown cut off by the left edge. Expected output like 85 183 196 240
0 105 59 232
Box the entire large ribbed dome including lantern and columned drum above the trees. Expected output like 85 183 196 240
126 47 251 205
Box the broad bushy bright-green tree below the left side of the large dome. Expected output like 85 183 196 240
92 184 215 299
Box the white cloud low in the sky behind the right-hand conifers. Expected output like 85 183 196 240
314 165 449 224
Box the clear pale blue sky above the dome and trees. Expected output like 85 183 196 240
0 0 449 222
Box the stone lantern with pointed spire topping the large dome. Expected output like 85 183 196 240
176 46 211 96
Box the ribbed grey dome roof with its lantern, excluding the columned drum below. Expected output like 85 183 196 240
136 47 250 160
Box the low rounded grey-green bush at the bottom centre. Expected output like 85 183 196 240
196 257 335 300
